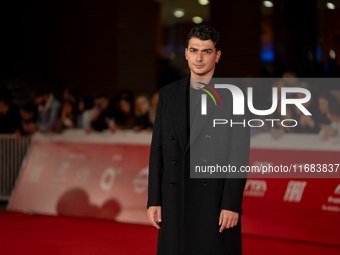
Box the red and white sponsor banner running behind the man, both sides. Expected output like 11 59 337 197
8 131 340 245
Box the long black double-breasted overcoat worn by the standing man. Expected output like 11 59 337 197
147 76 250 255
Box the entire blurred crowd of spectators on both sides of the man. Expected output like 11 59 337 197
0 72 340 143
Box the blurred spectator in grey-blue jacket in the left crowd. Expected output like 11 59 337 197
34 86 61 132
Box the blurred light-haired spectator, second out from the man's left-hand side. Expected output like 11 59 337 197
133 94 153 131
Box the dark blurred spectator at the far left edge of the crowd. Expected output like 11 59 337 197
0 97 20 134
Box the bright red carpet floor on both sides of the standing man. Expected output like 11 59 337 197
0 211 340 255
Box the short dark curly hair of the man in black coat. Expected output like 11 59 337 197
186 26 221 51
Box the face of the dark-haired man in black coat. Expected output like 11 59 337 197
185 38 221 78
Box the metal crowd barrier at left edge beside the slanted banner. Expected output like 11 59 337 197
0 134 31 200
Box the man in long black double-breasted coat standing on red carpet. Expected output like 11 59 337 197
147 26 250 255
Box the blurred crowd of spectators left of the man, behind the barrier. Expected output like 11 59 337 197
0 86 158 135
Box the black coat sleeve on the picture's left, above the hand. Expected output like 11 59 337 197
147 88 163 208
